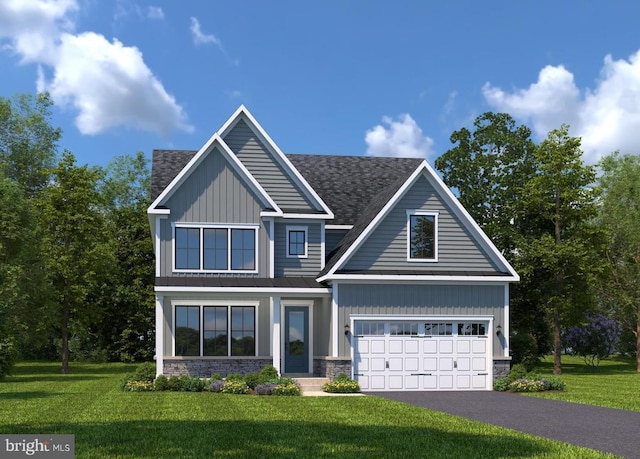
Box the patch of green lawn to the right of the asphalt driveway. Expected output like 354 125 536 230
527 355 640 412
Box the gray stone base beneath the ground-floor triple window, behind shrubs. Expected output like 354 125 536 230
162 357 273 378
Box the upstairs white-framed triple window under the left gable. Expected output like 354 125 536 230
173 224 258 272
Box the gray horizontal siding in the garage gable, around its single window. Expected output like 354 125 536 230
343 175 499 274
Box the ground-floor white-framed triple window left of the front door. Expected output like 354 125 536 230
174 302 257 357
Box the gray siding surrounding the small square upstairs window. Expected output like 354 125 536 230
274 220 322 277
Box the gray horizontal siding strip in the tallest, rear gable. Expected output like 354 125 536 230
223 120 317 213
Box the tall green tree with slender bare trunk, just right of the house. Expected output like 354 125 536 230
518 125 605 374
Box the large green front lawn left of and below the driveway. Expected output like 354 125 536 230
0 363 612 458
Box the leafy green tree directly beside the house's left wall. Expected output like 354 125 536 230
92 152 155 361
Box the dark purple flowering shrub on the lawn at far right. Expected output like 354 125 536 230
563 314 622 370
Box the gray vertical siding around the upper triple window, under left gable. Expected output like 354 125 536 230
160 148 269 277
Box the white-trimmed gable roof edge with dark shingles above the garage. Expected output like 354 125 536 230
318 161 519 281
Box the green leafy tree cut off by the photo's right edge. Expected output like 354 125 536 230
598 152 640 372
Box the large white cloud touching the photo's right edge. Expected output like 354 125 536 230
482 51 640 164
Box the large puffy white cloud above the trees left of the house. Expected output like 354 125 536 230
46 32 192 135
